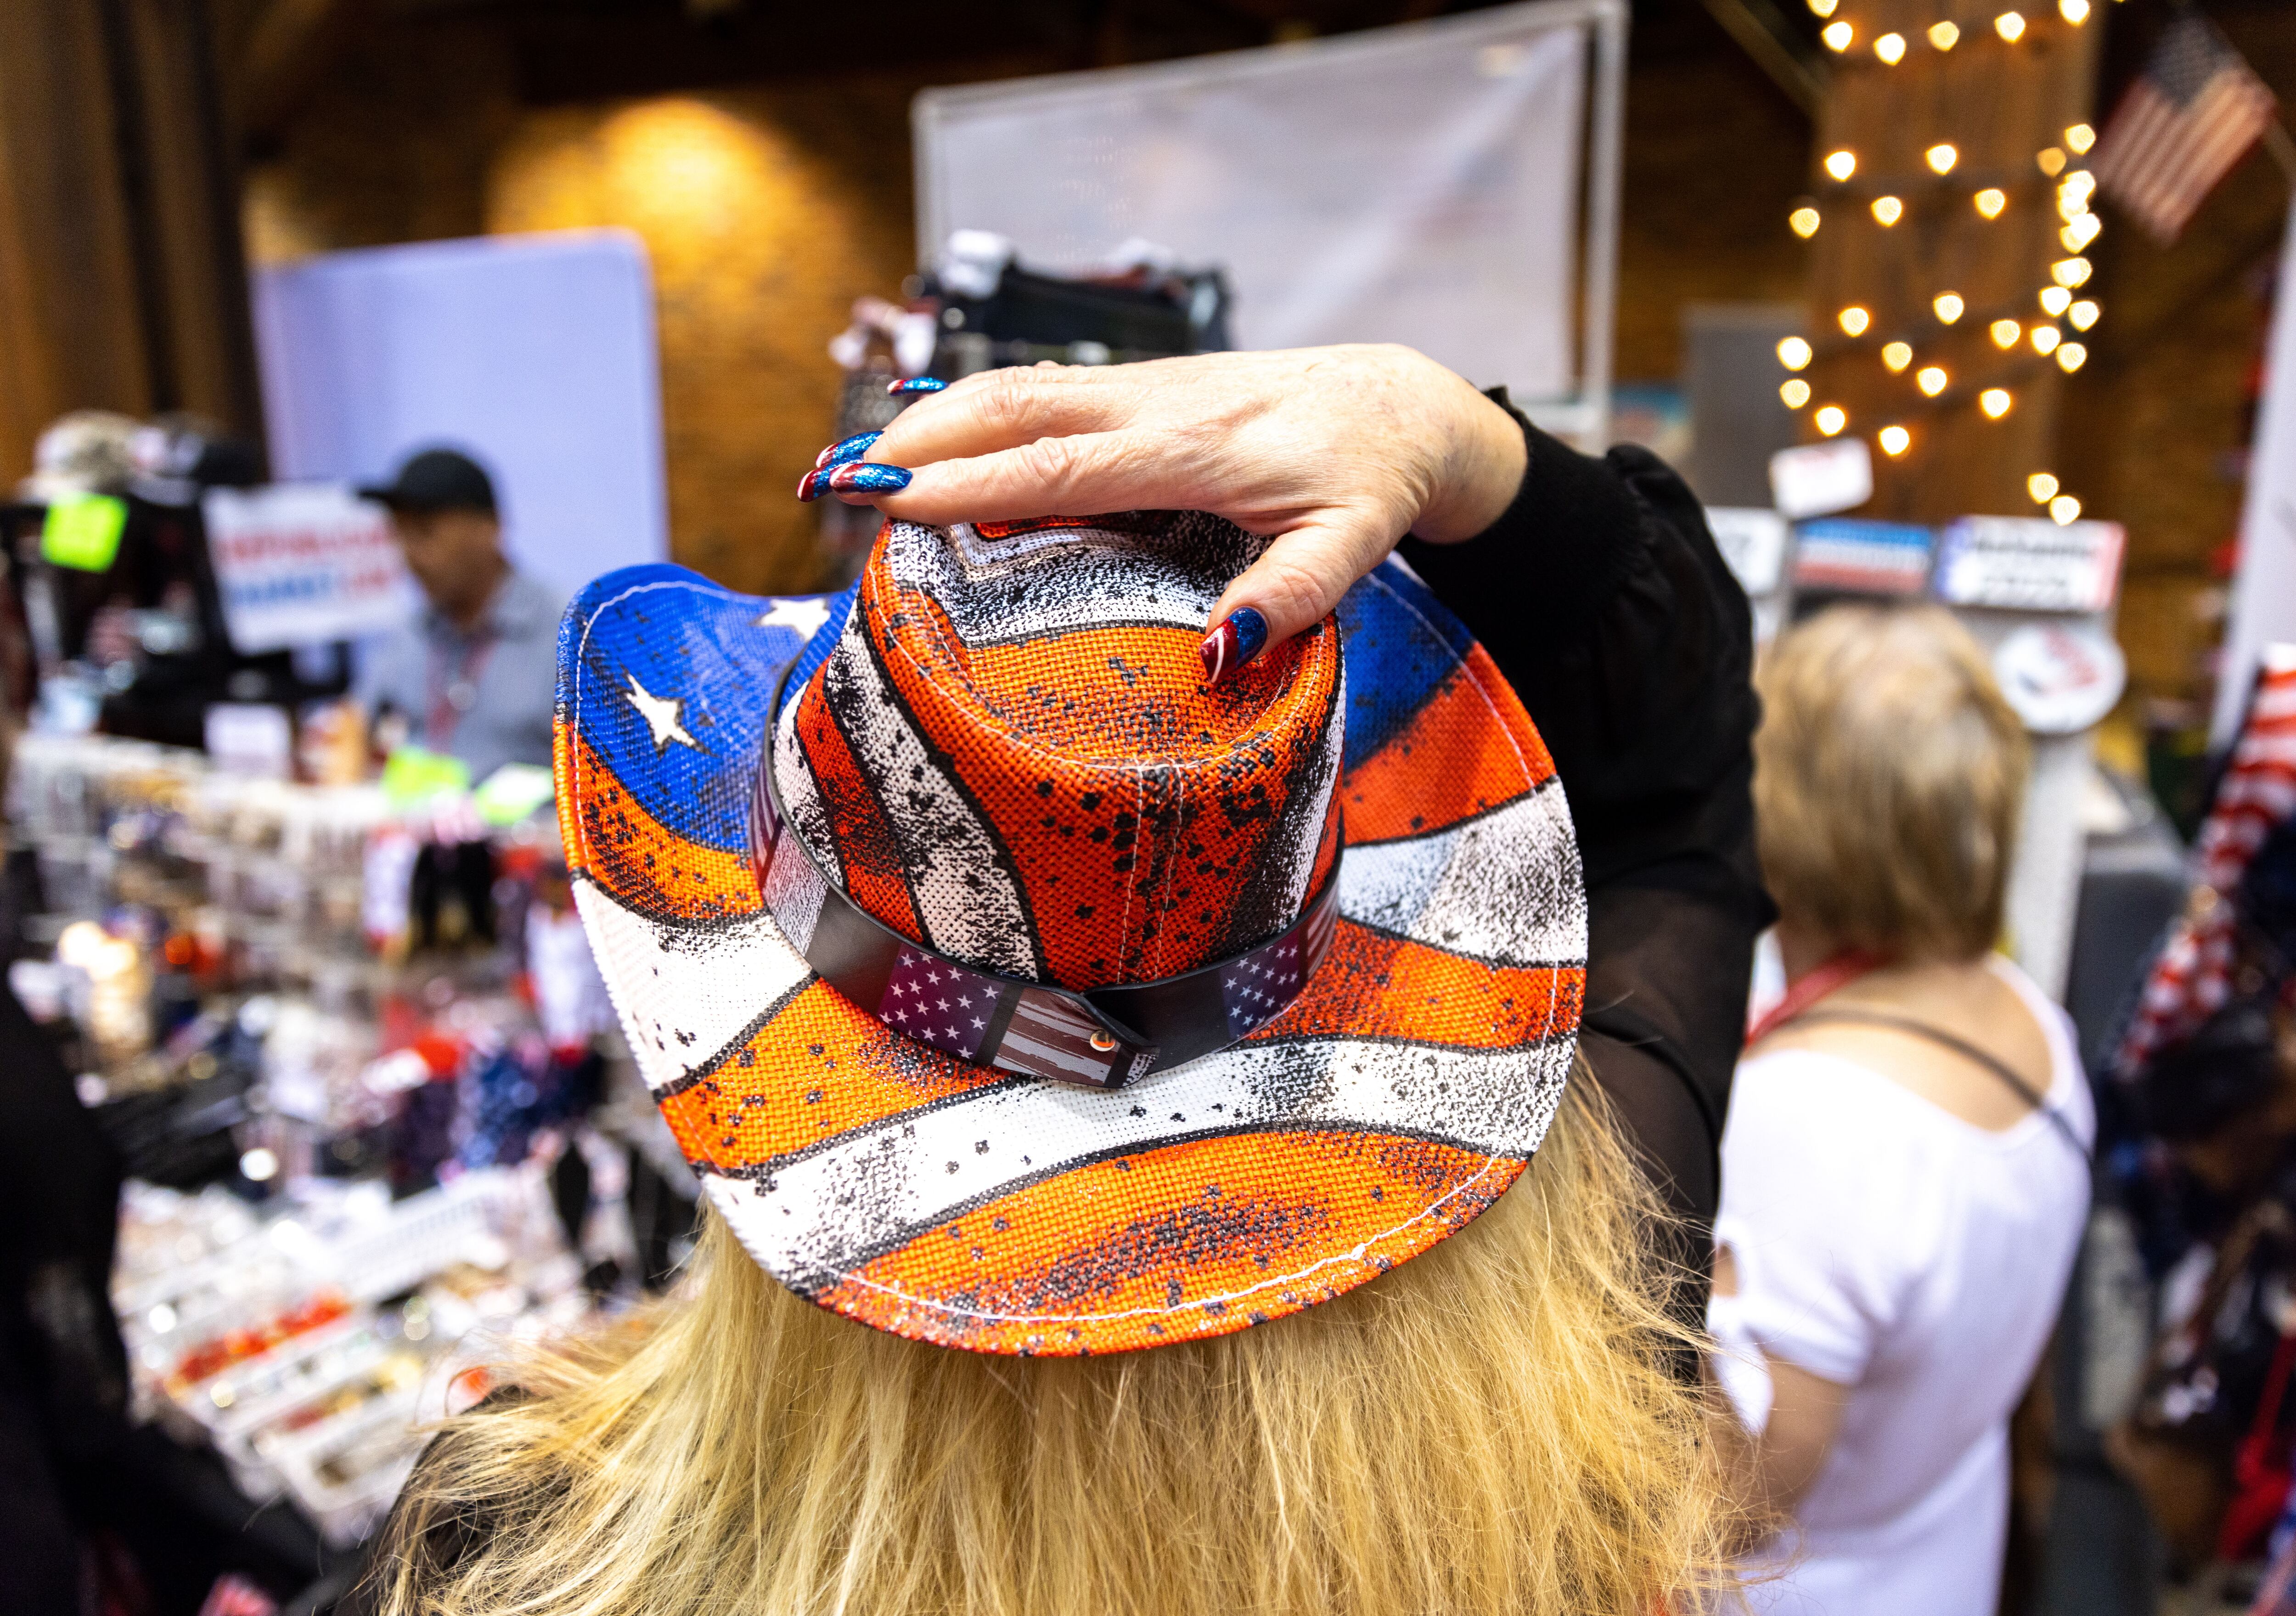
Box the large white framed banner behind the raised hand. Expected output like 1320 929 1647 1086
916 2 1623 417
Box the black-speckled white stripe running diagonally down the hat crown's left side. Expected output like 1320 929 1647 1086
822 627 1042 978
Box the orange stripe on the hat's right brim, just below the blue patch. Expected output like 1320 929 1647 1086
1339 645 1554 842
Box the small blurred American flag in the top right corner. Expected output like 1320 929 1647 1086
2092 11 2275 246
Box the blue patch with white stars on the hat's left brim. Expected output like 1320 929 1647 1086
558 563 820 851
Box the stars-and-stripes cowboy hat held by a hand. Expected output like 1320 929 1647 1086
558 512 1587 1354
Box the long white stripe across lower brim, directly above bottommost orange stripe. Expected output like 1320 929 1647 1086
705 1037 1573 1292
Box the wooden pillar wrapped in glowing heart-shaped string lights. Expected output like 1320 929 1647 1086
1789 0 2110 521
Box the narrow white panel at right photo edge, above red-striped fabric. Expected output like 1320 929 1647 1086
2209 211 2296 746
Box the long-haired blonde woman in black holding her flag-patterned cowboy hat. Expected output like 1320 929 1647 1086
358 349 1768 1616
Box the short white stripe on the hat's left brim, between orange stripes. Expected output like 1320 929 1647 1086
574 881 813 1090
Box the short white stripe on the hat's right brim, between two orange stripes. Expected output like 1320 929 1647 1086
1339 783 1587 964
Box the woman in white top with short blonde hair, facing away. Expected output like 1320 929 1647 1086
1708 606 2094 1616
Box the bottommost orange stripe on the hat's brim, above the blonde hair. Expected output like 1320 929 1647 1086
815 1129 1522 1352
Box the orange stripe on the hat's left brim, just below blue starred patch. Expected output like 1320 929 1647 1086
553 723 765 925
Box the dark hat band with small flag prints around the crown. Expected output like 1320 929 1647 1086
751 732 1339 1088
